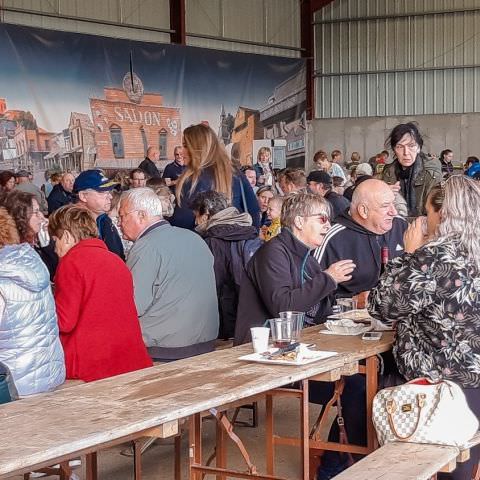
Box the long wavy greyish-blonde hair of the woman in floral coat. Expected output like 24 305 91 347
435 175 480 269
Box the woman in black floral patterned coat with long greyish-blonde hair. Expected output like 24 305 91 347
368 175 480 479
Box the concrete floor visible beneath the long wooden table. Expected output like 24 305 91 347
11 398 326 480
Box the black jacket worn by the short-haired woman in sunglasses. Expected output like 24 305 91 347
234 228 337 345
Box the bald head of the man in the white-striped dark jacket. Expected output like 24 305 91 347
350 179 397 235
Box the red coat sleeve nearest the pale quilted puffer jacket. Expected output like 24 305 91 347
55 258 84 333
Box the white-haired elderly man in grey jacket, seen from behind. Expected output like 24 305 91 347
118 188 219 361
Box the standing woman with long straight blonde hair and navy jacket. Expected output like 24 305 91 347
171 124 260 230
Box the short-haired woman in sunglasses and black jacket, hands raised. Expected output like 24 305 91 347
235 192 355 345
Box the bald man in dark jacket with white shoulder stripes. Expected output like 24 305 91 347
314 179 407 297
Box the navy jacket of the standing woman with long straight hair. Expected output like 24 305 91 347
170 170 260 230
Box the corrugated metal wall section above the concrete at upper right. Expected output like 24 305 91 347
315 0 480 118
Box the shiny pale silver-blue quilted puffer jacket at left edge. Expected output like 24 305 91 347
0 244 65 396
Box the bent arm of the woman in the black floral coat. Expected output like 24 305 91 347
367 249 435 325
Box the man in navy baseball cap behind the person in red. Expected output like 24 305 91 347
73 170 125 260
